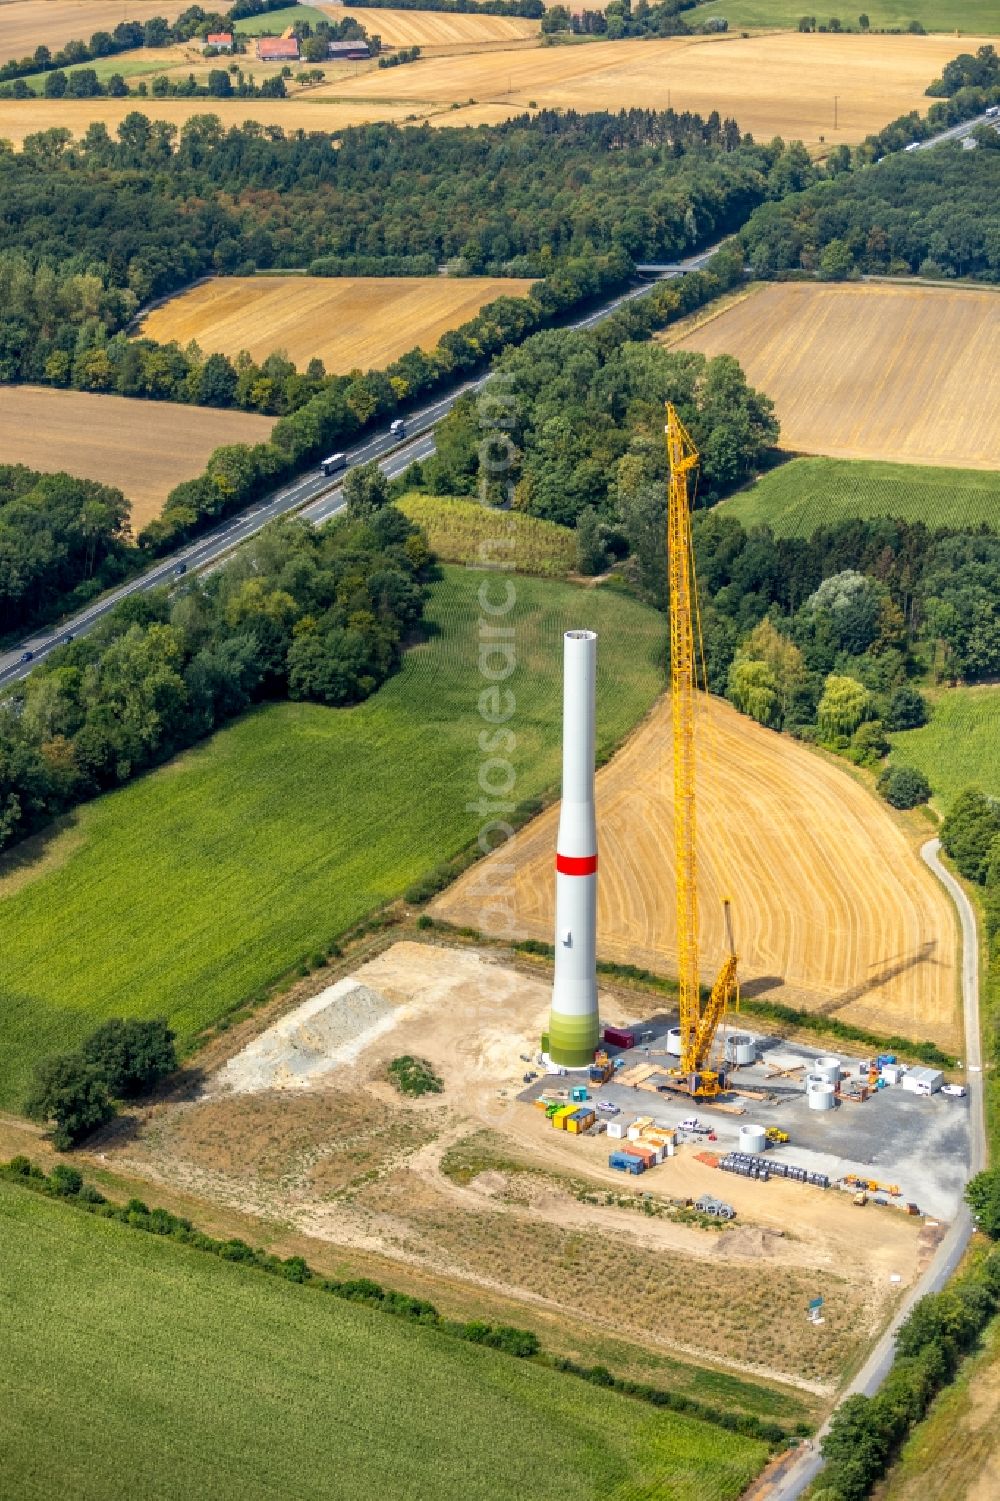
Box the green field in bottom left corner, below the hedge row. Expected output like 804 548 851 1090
0 1183 766 1501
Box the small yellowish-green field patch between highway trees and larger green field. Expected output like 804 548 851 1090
398 491 567 578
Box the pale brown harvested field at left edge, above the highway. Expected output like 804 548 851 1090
0 386 273 531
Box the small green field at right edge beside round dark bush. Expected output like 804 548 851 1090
890 686 1000 809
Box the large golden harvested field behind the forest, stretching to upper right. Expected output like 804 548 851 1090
317 32 976 147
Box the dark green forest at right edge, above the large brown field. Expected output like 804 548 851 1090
740 144 1000 282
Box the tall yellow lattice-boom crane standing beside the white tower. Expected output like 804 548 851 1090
665 402 739 1099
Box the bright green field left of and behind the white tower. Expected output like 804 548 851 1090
0 569 665 1108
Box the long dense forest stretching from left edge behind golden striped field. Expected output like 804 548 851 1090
0 110 768 301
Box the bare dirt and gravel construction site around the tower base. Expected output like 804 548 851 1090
101 941 965 1394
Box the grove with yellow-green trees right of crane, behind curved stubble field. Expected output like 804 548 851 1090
678 510 1000 774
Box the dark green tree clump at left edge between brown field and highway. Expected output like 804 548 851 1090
0 464 137 635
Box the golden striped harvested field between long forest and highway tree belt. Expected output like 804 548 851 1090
141 276 533 374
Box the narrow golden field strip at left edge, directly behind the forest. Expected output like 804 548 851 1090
0 90 426 147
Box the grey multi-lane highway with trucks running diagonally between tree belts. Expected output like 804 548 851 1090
0 245 719 690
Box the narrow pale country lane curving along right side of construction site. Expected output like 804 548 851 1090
767 839 986 1501
